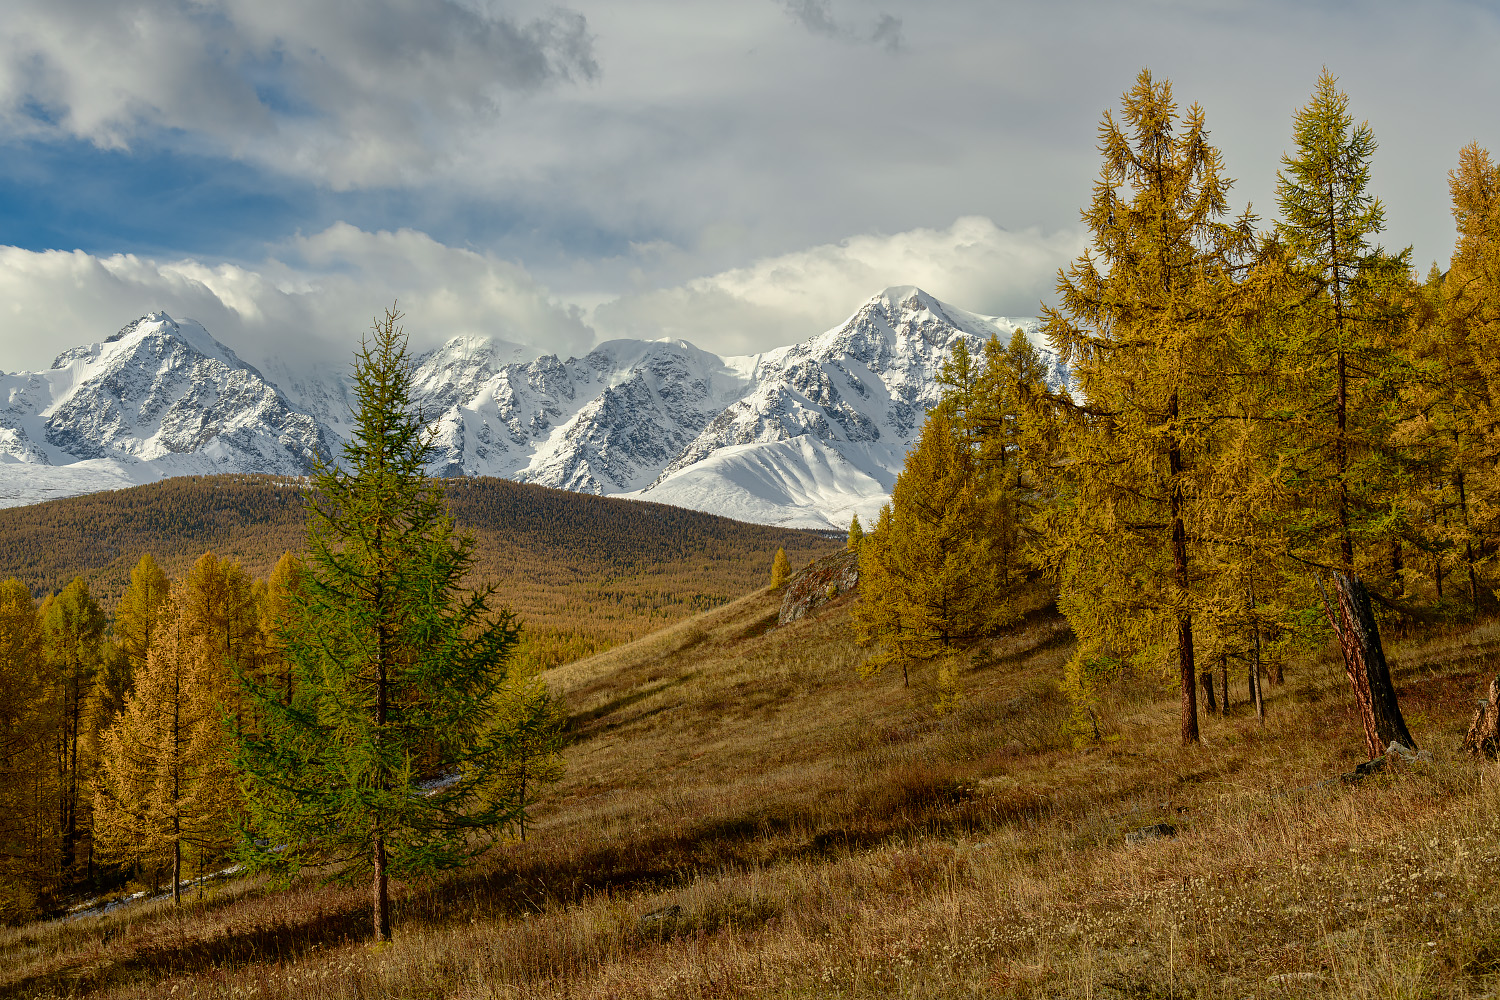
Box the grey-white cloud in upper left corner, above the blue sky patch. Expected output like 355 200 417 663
0 0 599 187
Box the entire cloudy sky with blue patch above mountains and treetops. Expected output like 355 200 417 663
0 0 1500 370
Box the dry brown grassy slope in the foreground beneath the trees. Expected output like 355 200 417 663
0 575 1500 1000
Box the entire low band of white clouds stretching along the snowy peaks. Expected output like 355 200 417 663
0 217 1082 370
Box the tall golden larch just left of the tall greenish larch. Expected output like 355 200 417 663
1044 70 1254 744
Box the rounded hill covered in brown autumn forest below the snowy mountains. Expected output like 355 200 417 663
0 475 839 651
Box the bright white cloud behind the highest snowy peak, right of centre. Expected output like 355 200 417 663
593 216 1083 354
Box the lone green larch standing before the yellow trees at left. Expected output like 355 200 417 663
237 310 524 940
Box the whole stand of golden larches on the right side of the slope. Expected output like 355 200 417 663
857 72 1500 742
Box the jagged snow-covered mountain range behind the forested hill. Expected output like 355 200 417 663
0 288 1062 528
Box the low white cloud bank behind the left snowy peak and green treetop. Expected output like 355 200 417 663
0 223 593 370
